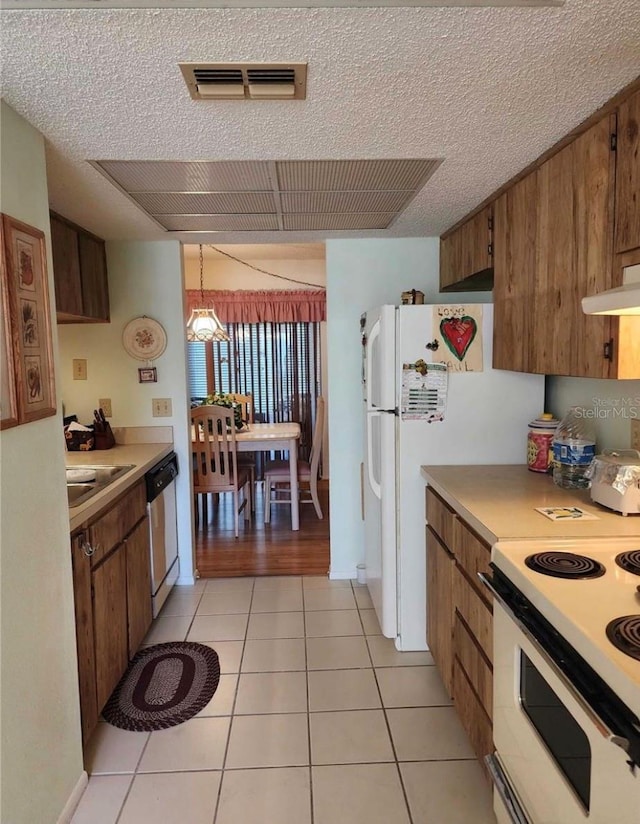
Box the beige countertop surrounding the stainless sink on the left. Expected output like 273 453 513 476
65 443 173 532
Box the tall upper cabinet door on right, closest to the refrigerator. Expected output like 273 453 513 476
493 172 538 372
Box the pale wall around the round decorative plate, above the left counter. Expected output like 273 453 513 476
58 240 195 583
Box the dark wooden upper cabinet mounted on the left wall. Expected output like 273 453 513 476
50 212 109 323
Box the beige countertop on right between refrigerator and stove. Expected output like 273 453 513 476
421 465 640 545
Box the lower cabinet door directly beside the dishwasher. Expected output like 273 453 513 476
125 517 153 659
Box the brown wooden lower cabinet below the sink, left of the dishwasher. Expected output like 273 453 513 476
71 483 152 744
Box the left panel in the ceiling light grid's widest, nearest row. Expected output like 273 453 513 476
96 160 272 193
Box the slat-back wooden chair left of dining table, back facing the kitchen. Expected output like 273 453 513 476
191 406 253 538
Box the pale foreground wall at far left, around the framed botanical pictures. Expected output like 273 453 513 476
0 103 83 824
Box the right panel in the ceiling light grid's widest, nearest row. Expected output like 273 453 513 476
276 159 442 192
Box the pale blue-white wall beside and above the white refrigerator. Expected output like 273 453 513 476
326 238 492 578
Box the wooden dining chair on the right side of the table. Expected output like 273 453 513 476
264 397 325 524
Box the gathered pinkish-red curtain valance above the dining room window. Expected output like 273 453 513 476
187 289 327 323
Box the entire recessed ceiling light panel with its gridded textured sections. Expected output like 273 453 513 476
93 158 442 232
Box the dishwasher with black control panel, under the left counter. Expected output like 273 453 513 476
145 452 180 618
